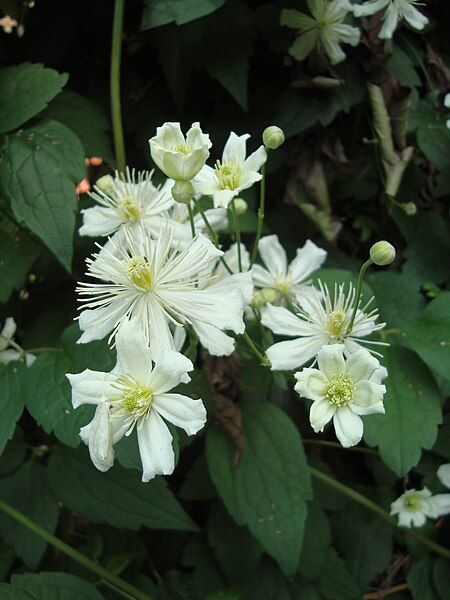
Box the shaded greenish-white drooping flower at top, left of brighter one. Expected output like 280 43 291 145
280 0 361 65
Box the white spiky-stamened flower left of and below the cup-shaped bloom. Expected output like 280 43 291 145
80 168 175 237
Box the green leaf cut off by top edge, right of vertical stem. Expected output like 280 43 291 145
141 0 225 31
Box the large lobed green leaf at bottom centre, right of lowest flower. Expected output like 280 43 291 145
207 402 311 575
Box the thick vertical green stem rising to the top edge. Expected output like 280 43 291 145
110 0 126 173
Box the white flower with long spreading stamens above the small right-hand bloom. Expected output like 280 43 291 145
262 282 385 370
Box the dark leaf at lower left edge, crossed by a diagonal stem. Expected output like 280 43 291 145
0 462 58 569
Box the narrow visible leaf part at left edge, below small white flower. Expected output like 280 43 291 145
0 361 26 454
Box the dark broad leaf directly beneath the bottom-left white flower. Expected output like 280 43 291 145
48 447 197 531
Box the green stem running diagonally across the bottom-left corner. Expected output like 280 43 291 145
0 499 152 600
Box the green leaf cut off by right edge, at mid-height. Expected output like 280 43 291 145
405 292 450 379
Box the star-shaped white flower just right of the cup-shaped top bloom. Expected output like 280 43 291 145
193 131 267 208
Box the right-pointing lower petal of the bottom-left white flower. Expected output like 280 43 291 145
153 394 206 435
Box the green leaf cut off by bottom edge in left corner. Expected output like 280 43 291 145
0 572 103 600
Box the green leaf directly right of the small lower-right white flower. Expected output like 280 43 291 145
364 346 442 477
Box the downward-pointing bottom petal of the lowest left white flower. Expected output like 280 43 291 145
137 410 175 482
